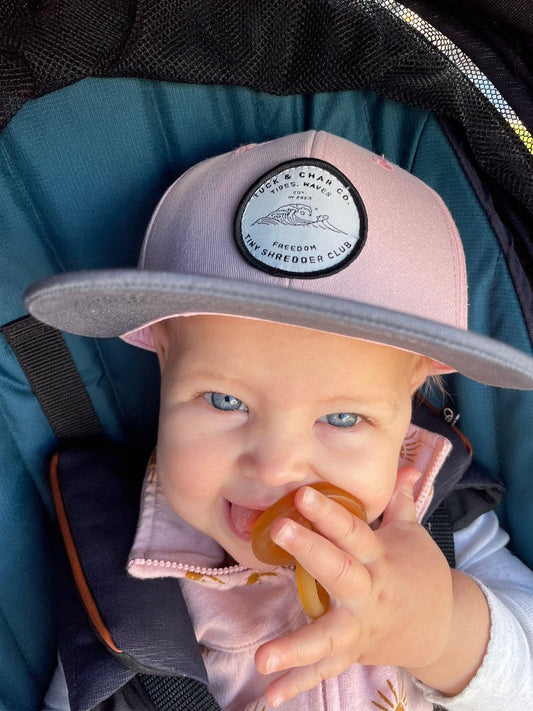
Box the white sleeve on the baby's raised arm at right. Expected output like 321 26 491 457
423 512 533 711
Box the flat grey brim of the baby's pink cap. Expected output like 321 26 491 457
25 269 533 390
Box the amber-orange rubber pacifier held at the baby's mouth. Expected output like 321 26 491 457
251 481 366 619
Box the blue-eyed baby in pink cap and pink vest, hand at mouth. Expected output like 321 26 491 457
28 132 533 711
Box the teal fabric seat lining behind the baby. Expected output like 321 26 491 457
0 79 533 710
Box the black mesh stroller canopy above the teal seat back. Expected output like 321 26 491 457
0 0 533 253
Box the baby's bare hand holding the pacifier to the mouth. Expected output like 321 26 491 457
256 468 453 706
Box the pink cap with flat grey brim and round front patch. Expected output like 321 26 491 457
25 131 533 389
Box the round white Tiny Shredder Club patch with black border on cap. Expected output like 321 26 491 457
235 158 367 279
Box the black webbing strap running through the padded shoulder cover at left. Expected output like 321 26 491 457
0 316 220 711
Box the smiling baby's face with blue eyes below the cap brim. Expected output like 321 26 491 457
154 316 427 567
